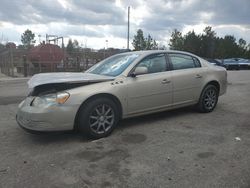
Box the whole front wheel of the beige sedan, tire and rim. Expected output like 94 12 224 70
78 97 119 139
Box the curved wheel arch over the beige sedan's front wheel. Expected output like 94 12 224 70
74 93 123 129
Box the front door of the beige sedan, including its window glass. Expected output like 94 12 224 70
126 54 172 115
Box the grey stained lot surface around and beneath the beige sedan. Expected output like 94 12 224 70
0 71 250 188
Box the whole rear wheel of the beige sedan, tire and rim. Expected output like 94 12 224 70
197 84 219 113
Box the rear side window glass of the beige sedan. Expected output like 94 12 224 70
169 53 201 70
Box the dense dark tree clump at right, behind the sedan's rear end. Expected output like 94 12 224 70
169 26 250 59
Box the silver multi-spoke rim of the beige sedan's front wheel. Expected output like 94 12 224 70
89 104 115 134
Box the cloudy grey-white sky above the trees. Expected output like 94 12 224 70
0 0 250 49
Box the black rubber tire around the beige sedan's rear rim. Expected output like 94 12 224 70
198 85 219 113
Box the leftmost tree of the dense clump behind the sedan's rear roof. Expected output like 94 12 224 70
169 29 184 50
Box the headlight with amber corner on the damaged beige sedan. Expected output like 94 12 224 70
31 92 70 107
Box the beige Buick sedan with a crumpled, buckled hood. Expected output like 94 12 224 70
16 50 227 138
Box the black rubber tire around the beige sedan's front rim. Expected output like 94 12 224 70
78 97 119 139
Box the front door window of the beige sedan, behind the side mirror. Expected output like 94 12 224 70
137 54 167 73
